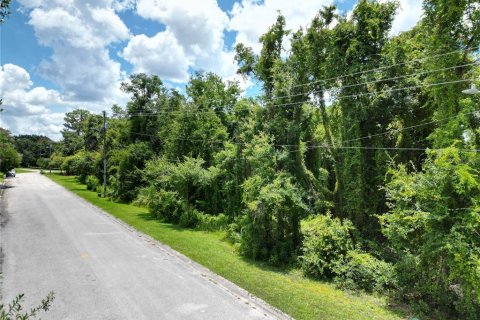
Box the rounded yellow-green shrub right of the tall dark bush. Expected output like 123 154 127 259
300 215 355 278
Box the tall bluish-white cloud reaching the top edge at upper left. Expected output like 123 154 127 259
19 0 133 103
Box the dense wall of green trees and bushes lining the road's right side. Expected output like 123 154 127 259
50 0 480 319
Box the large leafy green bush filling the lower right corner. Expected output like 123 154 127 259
381 147 480 319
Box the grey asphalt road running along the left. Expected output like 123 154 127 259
0 173 285 320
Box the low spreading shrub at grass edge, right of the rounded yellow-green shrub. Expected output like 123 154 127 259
334 250 396 293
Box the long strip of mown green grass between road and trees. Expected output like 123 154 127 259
46 174 405 320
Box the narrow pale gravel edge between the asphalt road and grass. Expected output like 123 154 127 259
45 176 294 320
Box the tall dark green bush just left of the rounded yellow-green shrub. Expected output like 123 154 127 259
239 171 308 264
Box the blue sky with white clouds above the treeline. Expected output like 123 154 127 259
0 0 422 140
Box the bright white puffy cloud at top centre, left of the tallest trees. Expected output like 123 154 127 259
122 0 236 82
